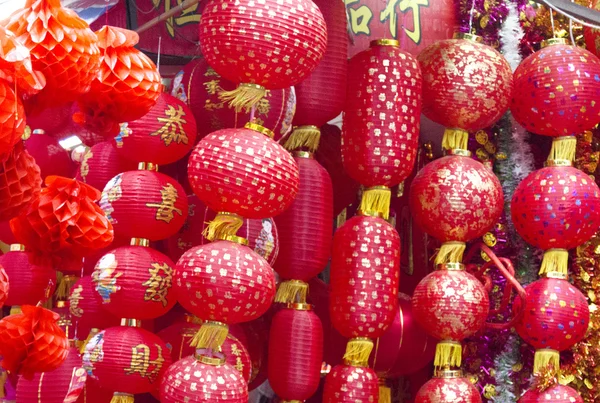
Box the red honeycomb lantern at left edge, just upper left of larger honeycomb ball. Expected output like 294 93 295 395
0 144 42 221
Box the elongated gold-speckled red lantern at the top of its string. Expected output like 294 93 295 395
342 40 422 187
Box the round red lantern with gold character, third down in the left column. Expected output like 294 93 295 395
92 244 176 320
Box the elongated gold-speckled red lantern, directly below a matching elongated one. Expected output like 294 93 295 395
329 216 400 338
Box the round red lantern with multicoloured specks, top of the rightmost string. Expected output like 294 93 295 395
510 41 600 136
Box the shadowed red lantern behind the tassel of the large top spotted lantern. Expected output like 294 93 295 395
172 58 296 140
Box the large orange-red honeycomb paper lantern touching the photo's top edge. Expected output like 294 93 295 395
4 0 100 111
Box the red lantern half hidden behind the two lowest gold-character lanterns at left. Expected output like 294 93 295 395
69 276 120 340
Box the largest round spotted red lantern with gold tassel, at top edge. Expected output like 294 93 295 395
200 0 327 110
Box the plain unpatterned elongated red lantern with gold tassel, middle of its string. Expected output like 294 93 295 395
274 151 333 304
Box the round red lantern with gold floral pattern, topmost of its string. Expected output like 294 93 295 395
418 39 513 131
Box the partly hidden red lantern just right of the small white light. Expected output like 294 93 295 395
75 141 137 191
